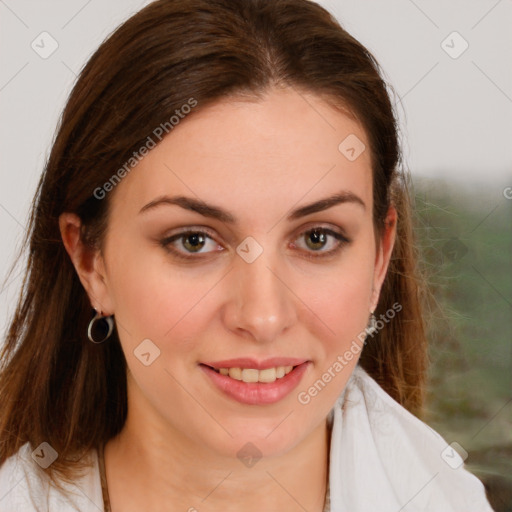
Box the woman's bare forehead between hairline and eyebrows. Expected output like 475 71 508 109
112 88 371 223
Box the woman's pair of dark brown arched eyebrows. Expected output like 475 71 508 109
139 190 366 224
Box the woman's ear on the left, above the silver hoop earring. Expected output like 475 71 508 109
59 212 113 316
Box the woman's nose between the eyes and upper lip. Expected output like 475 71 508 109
223 251 298 343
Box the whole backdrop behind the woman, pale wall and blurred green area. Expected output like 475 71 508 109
0 0 512 512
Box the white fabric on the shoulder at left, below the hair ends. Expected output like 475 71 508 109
0 443 103 512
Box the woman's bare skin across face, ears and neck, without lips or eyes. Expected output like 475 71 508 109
60 88 396 512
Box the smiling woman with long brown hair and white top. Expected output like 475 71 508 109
0 0 492 512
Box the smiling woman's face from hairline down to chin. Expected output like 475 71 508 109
82 88 394 457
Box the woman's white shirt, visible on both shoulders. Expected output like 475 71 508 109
0 365 493 512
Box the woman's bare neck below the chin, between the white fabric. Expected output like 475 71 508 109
105 390 331 512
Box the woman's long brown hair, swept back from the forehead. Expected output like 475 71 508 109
0 0 427 488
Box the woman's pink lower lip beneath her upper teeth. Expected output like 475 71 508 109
199 361 309 405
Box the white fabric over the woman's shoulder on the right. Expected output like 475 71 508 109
330 365 492 512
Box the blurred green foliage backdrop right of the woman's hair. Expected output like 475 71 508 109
413 174 512 512
